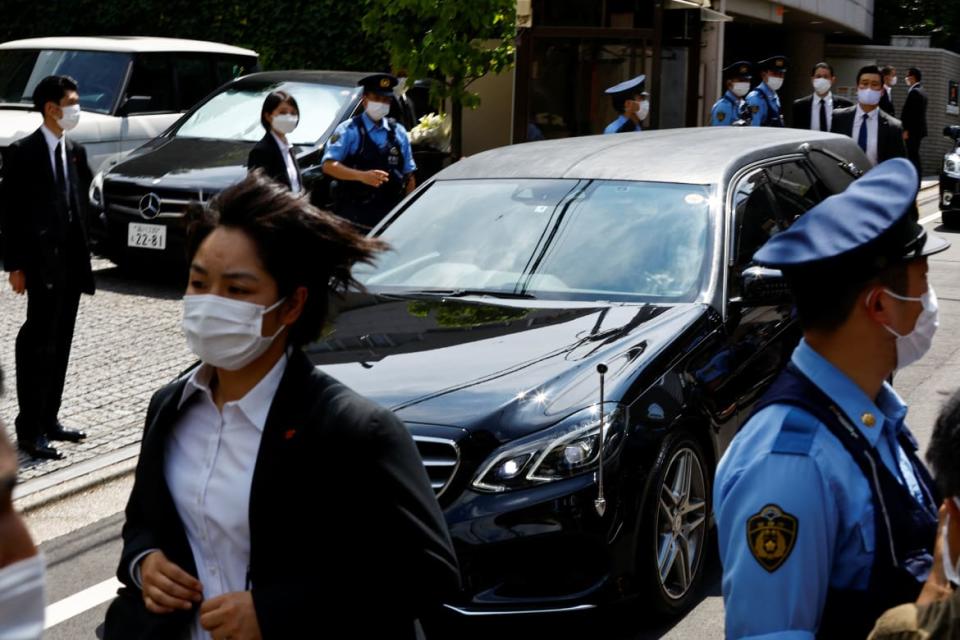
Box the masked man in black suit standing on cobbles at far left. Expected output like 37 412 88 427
0 76 94 460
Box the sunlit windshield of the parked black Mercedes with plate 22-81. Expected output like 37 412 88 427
175 82 359 145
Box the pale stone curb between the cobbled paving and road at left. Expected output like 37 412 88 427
13 442 140 513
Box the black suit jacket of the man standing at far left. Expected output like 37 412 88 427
0 129 94 293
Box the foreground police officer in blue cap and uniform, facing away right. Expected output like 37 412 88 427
713 158 948 639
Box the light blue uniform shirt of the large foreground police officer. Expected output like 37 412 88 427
713 341 923 639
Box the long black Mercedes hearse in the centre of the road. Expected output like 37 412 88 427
310 127 869 618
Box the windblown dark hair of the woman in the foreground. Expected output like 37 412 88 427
187 169 387 347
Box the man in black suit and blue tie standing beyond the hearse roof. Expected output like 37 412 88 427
830 65 907 165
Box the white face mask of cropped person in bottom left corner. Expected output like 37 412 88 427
0 555 46 640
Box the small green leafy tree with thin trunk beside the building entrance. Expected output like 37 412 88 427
363 0 516 155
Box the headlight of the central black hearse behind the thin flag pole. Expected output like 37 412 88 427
473 403 627 492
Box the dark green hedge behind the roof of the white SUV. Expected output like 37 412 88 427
0 0 388 71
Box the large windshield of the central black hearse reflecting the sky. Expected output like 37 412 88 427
355 179 711 302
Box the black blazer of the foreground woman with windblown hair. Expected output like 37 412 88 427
105 350 459 640
